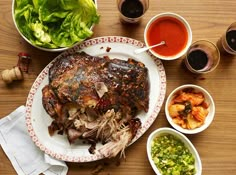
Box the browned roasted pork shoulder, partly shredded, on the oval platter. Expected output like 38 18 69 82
42 52 149 157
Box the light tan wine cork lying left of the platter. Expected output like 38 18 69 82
1 66 23 84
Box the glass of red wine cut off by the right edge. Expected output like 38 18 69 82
217 22 236 55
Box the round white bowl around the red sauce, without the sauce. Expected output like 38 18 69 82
144 12 192 60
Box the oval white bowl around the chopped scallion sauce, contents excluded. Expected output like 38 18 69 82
147 128 202 175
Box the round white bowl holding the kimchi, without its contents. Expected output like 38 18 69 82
165 84 215 134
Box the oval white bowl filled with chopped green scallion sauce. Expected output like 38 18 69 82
147 127 202 175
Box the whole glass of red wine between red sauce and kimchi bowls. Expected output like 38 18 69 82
184 40 220 74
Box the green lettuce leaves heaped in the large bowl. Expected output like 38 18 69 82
14 0 99 48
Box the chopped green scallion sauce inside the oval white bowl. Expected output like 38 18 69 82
151 134 196 175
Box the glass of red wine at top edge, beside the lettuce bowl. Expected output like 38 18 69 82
117 0 149 23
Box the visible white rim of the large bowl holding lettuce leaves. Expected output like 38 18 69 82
12 0 97 52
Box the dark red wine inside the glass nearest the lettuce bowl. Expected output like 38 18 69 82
121 0 144 18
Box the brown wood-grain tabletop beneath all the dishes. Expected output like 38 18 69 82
0 0 236 175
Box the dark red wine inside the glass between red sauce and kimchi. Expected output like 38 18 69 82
188 49 208 70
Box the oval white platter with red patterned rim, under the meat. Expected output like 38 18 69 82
26 36 166 162
